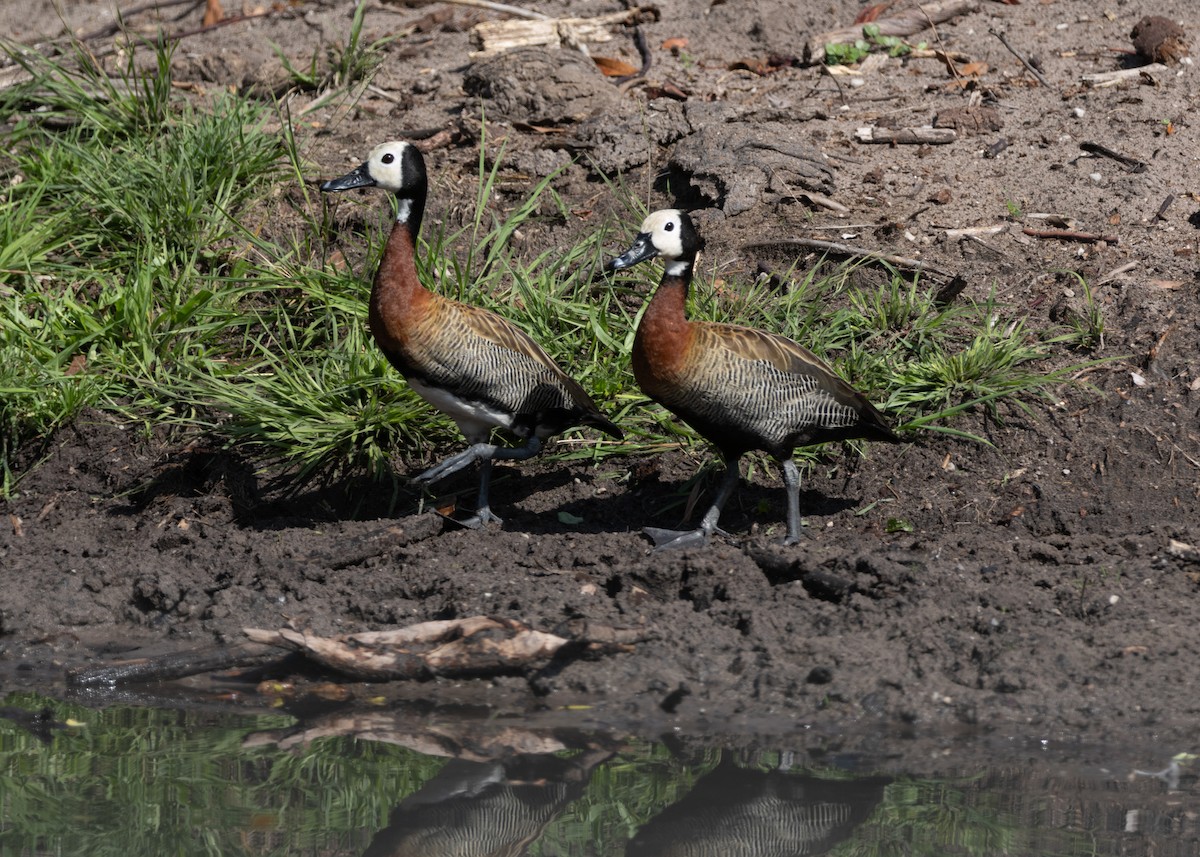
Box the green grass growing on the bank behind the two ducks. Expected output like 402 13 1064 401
0 36 1094 496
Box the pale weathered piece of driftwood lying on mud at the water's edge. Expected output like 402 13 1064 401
245 616 648 682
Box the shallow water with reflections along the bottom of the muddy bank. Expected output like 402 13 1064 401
0 691 1200 857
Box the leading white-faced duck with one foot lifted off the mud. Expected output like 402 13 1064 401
320 140 623 520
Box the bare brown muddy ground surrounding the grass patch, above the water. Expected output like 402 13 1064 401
0 0 1200 741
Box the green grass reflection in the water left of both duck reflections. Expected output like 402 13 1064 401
0 695 443 857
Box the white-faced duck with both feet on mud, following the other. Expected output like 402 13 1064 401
606 209 901 550
